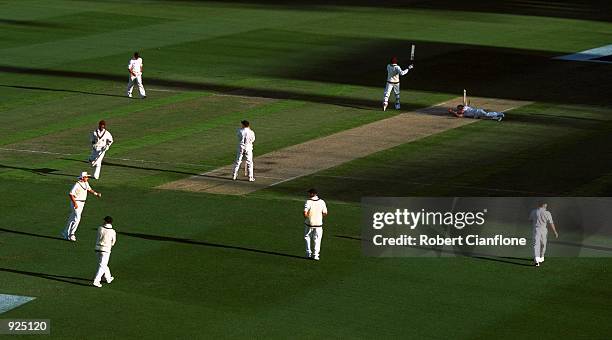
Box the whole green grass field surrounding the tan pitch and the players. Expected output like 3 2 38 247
0 0 612 339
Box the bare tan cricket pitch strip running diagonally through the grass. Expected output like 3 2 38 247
158 97 530 195
